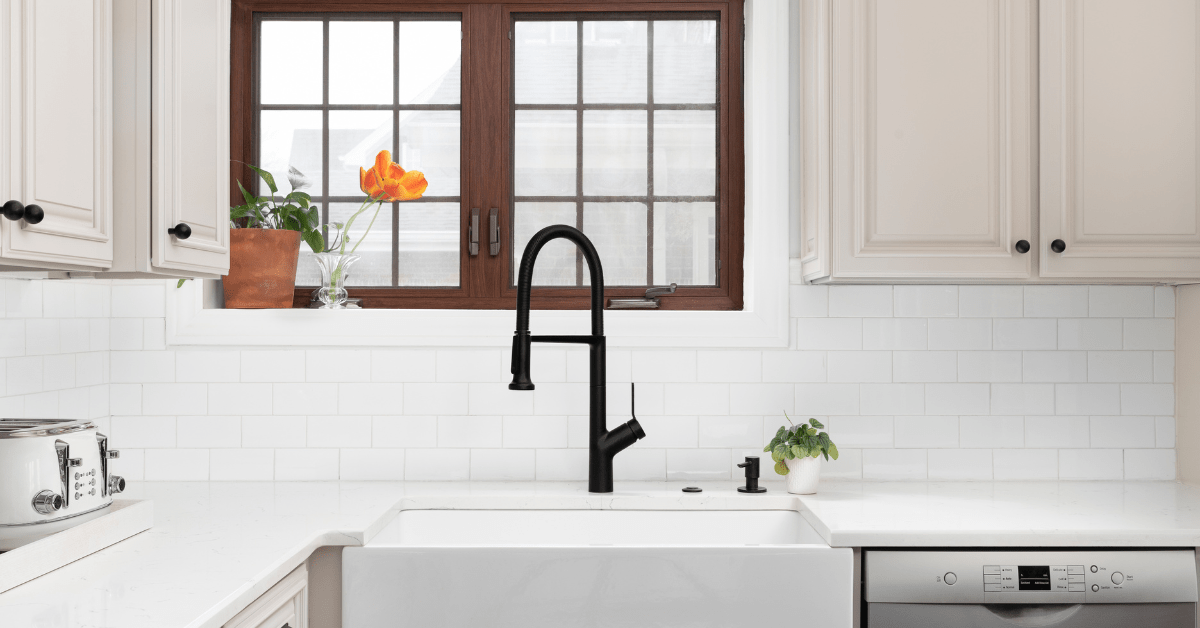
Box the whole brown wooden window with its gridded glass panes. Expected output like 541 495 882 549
230 0 744 310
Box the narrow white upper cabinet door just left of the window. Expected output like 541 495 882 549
151 0 229 274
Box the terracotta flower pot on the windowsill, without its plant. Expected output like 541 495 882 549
223 229 300 309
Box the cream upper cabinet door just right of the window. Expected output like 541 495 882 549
832 0 1033 280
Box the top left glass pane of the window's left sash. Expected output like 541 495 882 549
258 22 324 104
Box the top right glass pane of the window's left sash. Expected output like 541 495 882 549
400 22 462 104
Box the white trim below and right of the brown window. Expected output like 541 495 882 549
167 0 790 348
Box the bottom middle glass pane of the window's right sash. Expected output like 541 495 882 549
583 203 647 286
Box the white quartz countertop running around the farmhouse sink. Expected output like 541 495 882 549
0 482 1200 628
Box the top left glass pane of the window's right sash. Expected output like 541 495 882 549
514 22 578 104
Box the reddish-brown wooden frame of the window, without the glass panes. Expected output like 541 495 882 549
229 0 745 310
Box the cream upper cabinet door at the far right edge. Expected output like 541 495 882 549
1039 0 1200 281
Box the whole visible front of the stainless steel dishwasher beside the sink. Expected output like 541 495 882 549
863 549 1196 628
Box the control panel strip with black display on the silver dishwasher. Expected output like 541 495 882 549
863 549 1198 604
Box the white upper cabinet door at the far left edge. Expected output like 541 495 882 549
0 0 113 269
